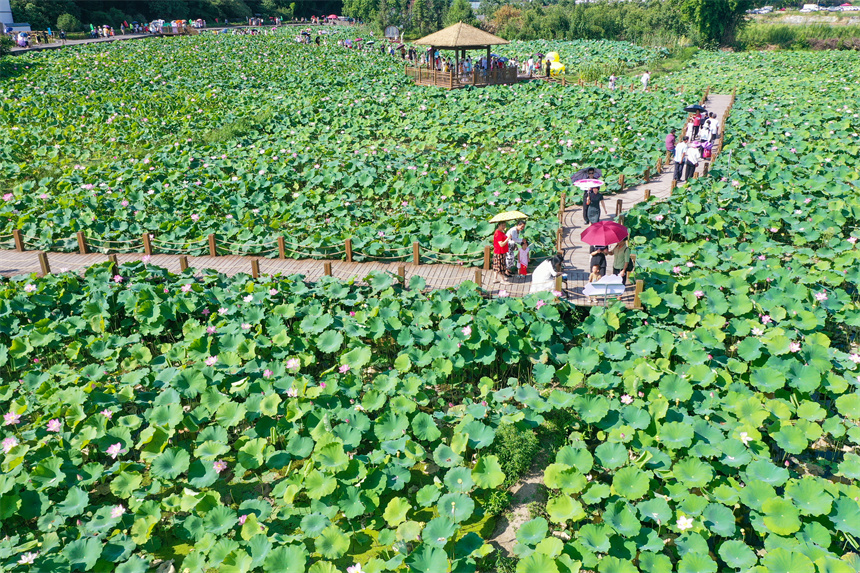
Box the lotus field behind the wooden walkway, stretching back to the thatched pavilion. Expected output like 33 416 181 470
0 29 684 261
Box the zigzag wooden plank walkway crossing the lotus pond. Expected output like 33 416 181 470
0 90 734 307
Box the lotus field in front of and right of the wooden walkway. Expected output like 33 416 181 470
0 39 860 573
